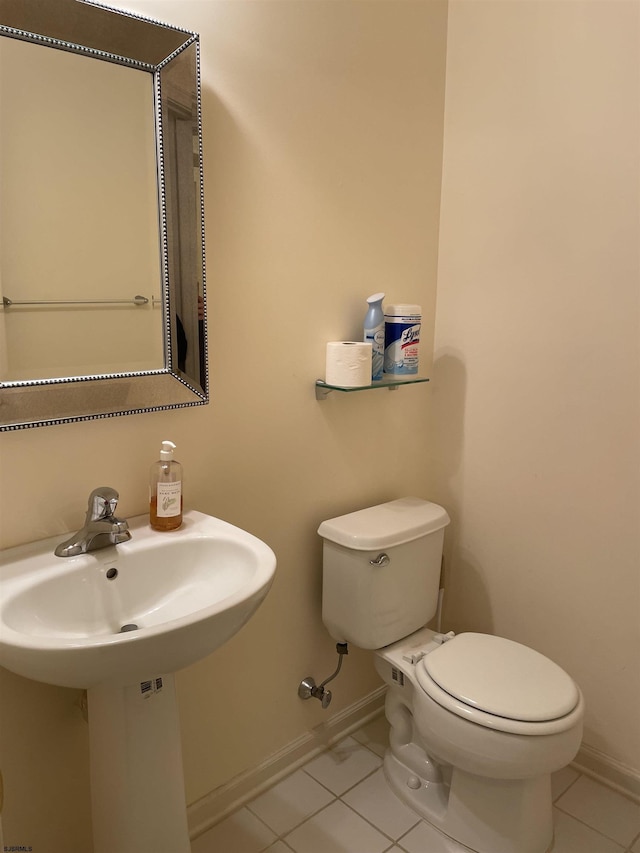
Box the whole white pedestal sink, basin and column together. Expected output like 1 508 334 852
0 511 276 853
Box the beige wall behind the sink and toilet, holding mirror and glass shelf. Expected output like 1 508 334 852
0 0 446 853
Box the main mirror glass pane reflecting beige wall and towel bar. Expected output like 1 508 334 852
0 38 164 382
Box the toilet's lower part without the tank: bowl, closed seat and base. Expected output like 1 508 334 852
374 629 584 853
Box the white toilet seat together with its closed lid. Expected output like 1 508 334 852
416 633 582 735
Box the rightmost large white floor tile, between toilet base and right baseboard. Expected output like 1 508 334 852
556 776 640 847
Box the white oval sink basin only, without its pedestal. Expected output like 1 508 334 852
0 511 276 688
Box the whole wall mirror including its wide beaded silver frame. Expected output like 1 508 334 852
0 0 208 430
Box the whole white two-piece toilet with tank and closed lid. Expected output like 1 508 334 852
318 497 584 853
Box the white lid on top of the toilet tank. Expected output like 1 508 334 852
318 498 450 551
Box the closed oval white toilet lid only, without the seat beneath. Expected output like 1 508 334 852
421 633 580 722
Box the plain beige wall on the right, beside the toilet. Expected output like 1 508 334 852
434 0 640 773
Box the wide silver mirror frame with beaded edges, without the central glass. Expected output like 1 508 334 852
0 0 209 431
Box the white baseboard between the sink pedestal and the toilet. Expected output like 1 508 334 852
187 684 386 840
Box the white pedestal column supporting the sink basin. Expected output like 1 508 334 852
87 675 190 853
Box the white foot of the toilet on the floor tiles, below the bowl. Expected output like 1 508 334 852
384 749 553 853
